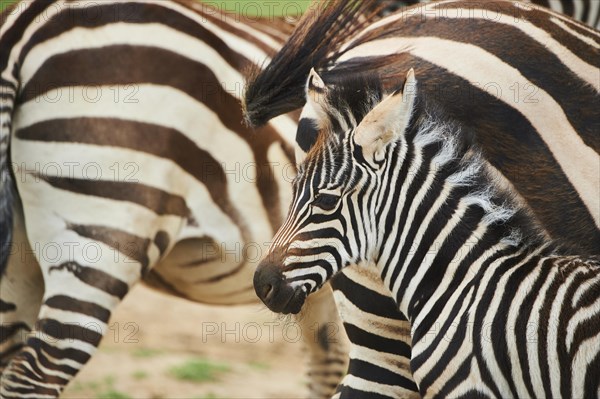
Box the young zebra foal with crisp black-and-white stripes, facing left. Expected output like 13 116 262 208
254 70 600 398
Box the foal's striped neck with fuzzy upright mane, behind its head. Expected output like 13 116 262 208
377 115 544 321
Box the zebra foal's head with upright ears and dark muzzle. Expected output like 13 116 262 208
254 69 416 313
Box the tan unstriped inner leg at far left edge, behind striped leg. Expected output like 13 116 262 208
0 204 44 374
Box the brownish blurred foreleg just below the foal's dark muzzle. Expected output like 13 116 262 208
298 284 348 398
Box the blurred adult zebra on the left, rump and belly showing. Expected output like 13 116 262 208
0 0 358 398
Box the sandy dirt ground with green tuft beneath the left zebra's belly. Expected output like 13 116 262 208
63 285 308 399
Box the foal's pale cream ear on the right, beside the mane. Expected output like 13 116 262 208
354 68 417 159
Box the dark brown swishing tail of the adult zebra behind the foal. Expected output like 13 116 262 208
242 0 382 126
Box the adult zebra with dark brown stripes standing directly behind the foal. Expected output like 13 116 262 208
246 2 600 397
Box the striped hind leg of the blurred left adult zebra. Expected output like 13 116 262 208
0 181 166 398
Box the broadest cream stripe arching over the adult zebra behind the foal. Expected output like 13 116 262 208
340 37 600 231
